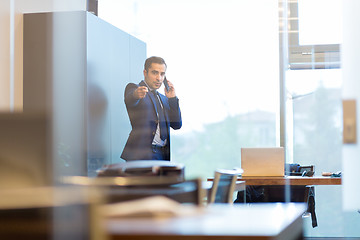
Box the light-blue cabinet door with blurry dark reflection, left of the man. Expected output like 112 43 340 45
87 14 130 169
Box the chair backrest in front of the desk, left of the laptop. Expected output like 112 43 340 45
208 170 241 203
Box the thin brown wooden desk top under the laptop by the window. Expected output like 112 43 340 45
208 176 341 186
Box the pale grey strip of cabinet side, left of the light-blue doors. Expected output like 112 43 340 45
48 12 87 175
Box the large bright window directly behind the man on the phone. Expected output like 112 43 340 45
98 0 279 178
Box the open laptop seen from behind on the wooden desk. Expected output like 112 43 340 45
241 147 285 177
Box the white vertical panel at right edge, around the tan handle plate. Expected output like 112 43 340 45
341 0 360 211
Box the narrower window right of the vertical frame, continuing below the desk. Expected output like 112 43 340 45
280 0 360 237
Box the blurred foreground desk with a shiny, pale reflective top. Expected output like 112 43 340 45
105 203 306 240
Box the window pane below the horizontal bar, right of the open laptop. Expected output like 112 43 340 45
287 69 342 174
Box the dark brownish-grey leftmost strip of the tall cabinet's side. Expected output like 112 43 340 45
23 13 53 111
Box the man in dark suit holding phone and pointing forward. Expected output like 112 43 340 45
121 57 182 161
